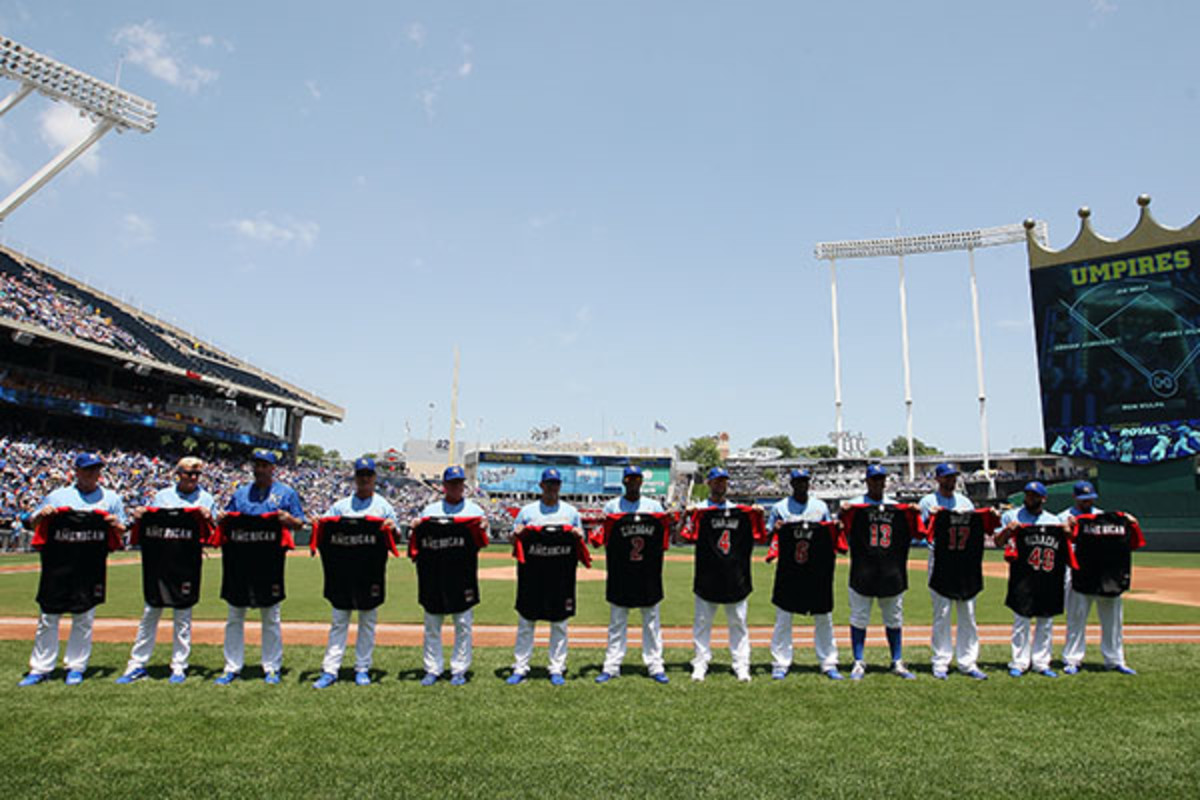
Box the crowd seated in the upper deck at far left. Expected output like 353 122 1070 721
0 267 151 357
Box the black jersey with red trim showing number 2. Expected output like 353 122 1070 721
592 512 671 608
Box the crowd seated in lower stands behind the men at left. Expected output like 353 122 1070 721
0 431 512 549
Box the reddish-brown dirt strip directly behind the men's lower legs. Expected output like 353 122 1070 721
0 616 1200 650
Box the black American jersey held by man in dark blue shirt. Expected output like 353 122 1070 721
217 511 295 608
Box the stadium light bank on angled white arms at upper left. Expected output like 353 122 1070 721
0 37 158 222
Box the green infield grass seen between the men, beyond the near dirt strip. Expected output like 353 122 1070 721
0 547 1200 626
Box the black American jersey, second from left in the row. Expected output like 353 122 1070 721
130 507 215 608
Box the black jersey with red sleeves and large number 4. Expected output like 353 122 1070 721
684 505 766 603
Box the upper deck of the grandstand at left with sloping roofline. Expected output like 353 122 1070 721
0 246 344 461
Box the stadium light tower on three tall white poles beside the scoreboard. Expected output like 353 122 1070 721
814 221 1048 498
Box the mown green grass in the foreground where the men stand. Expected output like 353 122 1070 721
0 642 1200 800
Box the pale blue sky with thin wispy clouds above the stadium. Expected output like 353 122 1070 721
0 0 1200 453
